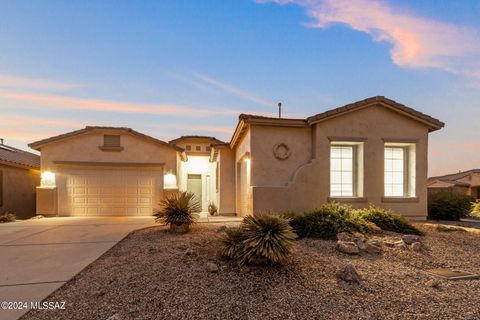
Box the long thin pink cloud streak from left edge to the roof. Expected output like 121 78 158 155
0 92 239 118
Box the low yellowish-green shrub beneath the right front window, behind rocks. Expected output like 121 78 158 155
355 205 423 235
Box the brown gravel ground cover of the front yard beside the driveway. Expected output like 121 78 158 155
22 224 480 320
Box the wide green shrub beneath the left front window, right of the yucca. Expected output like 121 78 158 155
287 202 368 240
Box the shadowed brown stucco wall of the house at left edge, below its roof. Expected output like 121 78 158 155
0 165 40 218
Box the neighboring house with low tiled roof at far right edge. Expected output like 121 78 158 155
427 169 480 199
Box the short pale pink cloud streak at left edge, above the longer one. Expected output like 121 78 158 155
0 74 84 91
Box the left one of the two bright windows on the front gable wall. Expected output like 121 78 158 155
330 146 354 197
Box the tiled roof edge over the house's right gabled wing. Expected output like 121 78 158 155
230 96 445 147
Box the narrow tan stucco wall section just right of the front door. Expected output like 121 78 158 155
217 148 235 215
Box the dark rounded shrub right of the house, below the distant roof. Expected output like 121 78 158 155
428 191 474 220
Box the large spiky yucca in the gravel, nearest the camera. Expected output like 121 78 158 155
220 214 297 265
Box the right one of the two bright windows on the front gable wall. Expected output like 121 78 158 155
384 144 415 197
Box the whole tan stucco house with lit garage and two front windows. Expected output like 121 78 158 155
30 97 444 219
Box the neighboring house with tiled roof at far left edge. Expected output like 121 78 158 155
0 139 40 218
